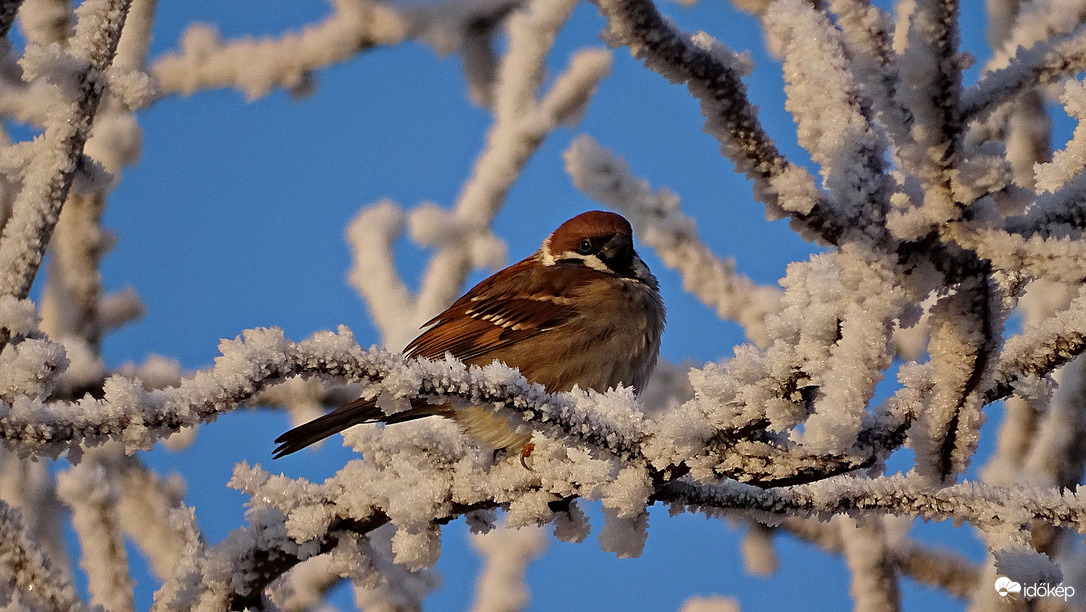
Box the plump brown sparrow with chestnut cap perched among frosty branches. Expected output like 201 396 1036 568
275 211 665 458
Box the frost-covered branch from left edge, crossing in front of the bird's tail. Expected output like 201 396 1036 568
0 328 642 456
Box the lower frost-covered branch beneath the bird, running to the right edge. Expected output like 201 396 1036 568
160 434 1086 608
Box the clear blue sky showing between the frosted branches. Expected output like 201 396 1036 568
63 0 1012 611
